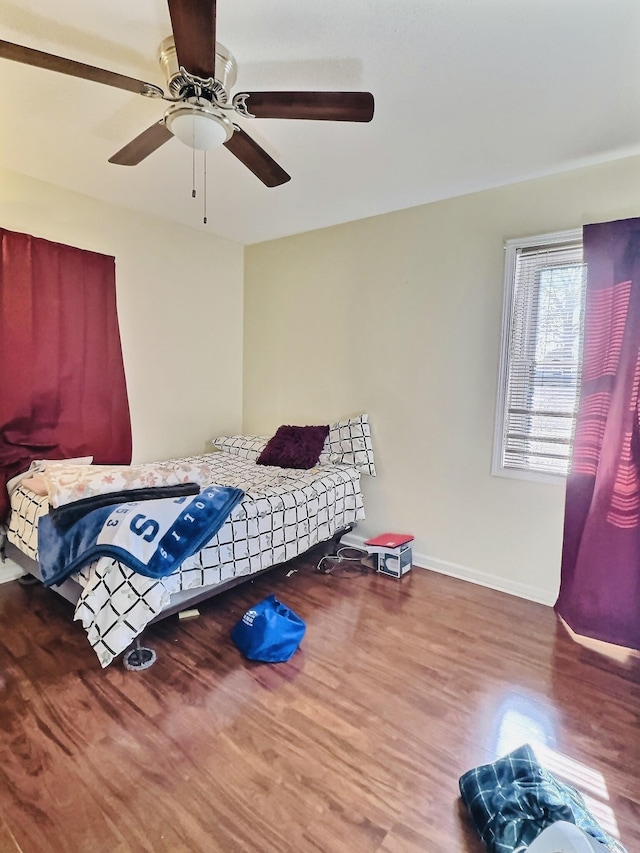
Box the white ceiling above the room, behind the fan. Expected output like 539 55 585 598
0 0 640 243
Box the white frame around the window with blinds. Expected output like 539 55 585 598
491 228 582 485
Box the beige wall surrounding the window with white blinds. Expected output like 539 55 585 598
244 158 640 602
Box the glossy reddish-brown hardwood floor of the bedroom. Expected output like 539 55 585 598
0 559 640 853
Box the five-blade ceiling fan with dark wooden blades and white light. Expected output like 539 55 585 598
0 0 373 187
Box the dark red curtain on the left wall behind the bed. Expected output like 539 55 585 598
0 228 131 521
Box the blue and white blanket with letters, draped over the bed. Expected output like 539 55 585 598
38 486 244 586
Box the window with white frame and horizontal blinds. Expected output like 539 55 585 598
492 231 586 480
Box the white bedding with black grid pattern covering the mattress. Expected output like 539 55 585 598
7 452 364 666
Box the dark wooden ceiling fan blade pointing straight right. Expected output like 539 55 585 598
239 92 373 121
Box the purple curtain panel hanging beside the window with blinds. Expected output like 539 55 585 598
555 219 640 649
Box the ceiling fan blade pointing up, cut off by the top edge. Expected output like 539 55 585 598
168 0 216 80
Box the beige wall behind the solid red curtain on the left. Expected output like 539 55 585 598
0 164 243 461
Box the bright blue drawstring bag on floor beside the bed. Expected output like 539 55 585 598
231 595 307 663
